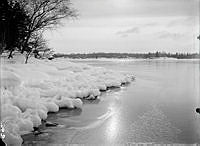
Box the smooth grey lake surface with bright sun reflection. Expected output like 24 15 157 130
23 59 200 145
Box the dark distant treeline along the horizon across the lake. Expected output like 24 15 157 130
54 51 200 59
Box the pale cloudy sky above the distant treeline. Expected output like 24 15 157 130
44 0 200 53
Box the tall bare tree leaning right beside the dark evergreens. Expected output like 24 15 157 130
19 0 77 56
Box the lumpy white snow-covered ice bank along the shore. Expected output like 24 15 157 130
0 59 132 145
